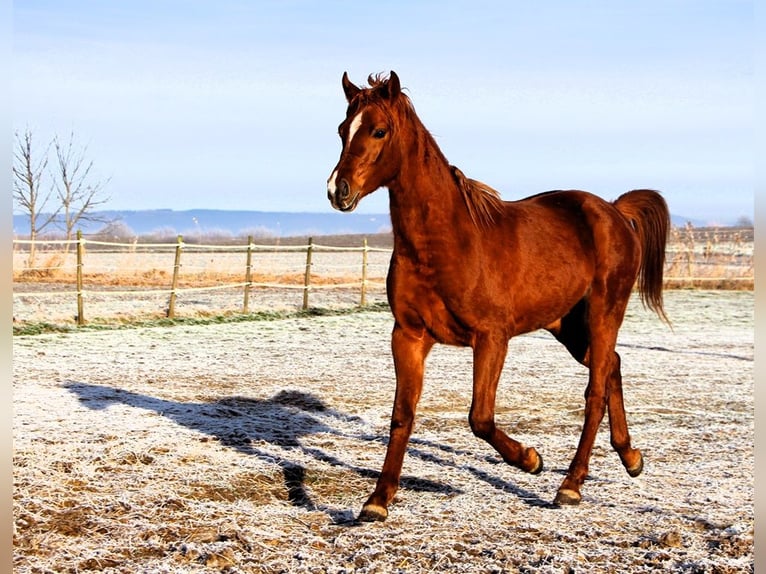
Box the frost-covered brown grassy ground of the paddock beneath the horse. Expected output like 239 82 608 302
13 291 754 573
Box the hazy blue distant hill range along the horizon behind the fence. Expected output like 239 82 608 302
13 209 720 239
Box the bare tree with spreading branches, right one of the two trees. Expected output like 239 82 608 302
53 133 109 240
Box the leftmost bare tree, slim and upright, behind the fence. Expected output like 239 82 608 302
13 128 61 267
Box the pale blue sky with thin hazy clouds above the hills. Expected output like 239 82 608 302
12 0 755 223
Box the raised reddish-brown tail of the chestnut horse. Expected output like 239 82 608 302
614 189 670 325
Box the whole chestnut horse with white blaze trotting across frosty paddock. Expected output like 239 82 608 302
327 72 669 520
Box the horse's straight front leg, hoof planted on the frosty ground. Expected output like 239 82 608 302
359 324 434 522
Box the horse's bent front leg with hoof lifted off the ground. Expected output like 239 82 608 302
469 335 543 474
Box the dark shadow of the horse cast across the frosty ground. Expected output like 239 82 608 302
63 381 544 524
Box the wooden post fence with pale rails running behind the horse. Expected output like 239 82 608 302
13 233 754 325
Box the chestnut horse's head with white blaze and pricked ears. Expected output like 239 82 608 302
327 72 408 211
